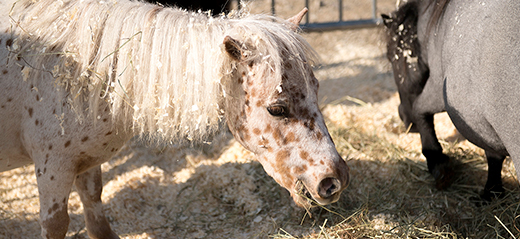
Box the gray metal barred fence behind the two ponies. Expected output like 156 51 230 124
271 0 381 32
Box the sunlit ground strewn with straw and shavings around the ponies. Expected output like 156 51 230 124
0 0 520 238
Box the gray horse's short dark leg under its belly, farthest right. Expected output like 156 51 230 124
480 150 506 201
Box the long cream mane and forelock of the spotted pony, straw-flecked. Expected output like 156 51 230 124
4 0 316 140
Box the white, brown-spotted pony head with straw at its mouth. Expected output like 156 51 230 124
219 10 349 207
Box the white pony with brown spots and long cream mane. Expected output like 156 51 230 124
0 0 349 238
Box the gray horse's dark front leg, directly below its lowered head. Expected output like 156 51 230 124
415 114 453 190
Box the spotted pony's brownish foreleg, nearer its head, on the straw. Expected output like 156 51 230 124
75 166 119 239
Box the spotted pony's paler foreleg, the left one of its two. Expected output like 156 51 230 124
35 161 75 239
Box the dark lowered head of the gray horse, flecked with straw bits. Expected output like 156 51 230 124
381 1 430 131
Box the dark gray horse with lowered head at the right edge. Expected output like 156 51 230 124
383 0 520 199
